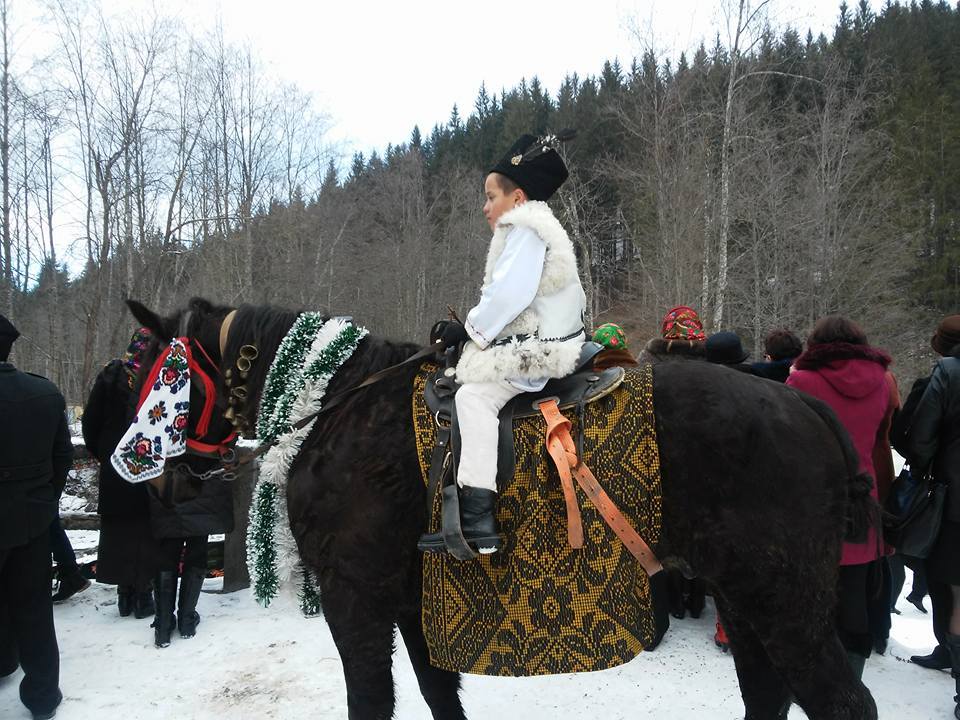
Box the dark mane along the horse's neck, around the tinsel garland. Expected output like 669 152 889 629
223 305 420 419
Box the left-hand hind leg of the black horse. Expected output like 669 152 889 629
713 590 790 720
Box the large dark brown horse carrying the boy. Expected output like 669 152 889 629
130 299 877 720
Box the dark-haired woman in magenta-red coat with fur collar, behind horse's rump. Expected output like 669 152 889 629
787 315 900 675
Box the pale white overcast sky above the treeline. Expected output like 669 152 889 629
95 0 864 154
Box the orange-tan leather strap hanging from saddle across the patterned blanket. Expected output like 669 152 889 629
539 399 663 576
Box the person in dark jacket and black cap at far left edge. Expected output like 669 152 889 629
0 315 73 720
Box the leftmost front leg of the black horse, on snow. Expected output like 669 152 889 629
320 572 394 720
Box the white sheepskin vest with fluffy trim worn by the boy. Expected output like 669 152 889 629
457 200 586 383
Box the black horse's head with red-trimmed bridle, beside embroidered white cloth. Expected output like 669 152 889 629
127 298 236 503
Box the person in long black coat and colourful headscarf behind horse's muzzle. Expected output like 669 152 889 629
81 328 157 618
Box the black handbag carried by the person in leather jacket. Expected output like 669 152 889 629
883 467 947 559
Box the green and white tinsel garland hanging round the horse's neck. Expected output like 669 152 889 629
247 313 367 614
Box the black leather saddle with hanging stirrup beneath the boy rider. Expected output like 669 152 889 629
424 342 625 560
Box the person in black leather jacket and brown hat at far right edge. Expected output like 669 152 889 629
906 315 960 718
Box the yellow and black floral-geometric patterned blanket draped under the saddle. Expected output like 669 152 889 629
413 365 661 677
